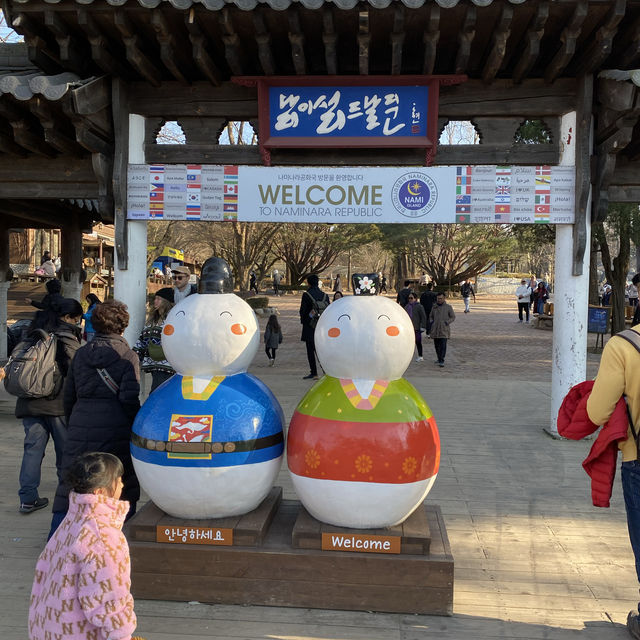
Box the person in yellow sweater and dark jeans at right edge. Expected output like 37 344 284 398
587 327 640 640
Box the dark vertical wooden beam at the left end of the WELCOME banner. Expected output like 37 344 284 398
111 78 130 270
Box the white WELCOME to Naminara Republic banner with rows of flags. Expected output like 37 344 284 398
127 165 575 224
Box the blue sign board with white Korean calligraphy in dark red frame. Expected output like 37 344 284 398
232 75 467 166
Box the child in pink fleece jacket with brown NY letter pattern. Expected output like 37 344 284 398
29 453 136 640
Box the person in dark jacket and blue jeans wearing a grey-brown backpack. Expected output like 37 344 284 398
15 298 82 514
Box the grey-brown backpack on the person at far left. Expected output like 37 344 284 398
4 329 62 400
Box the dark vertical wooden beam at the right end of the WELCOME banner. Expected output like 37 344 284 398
572 74 593 276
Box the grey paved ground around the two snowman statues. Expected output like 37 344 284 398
0 296 638 640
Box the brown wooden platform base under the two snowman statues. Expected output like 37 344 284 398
125 494 453 615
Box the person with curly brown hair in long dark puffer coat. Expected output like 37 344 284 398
49 300 140 537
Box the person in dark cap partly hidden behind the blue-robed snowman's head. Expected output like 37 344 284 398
133 287 175 392
